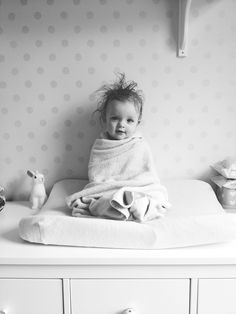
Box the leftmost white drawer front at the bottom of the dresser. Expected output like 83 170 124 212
0 279 63 314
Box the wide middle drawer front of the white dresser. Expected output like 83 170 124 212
71 279 189 314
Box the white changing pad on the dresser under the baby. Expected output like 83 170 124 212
19 179 236 249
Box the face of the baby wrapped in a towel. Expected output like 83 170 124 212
105 100 139 140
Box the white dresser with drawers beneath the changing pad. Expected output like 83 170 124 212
0 202 236 314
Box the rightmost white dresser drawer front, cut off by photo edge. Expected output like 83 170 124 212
198 279 236 314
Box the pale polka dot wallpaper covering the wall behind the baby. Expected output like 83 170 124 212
0 0 236 199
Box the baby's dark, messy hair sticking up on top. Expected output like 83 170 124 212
94 73 144 122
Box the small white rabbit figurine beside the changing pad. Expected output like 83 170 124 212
27 170 47 209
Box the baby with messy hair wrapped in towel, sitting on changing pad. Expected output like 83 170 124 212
67 74 170 222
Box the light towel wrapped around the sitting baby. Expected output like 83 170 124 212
67 135 170 221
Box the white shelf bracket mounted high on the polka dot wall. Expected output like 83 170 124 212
177 0 192 57
